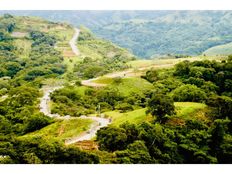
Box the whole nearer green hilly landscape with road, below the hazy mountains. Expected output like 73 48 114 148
0 14 232 164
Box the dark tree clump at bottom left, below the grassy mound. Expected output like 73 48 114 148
5 136 99 164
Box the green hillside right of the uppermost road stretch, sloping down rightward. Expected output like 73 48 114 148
73 27 136 79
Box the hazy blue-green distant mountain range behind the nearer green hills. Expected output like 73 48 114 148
0 11 232 58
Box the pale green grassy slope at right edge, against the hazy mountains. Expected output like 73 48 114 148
203 43 232 56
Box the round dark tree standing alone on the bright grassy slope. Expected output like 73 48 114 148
147 94 175 123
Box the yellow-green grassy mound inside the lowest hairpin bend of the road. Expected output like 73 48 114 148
23 118 93 141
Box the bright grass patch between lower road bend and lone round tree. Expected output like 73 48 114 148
105 108 152 126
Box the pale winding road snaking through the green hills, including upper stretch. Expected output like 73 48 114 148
39 28 110 145
